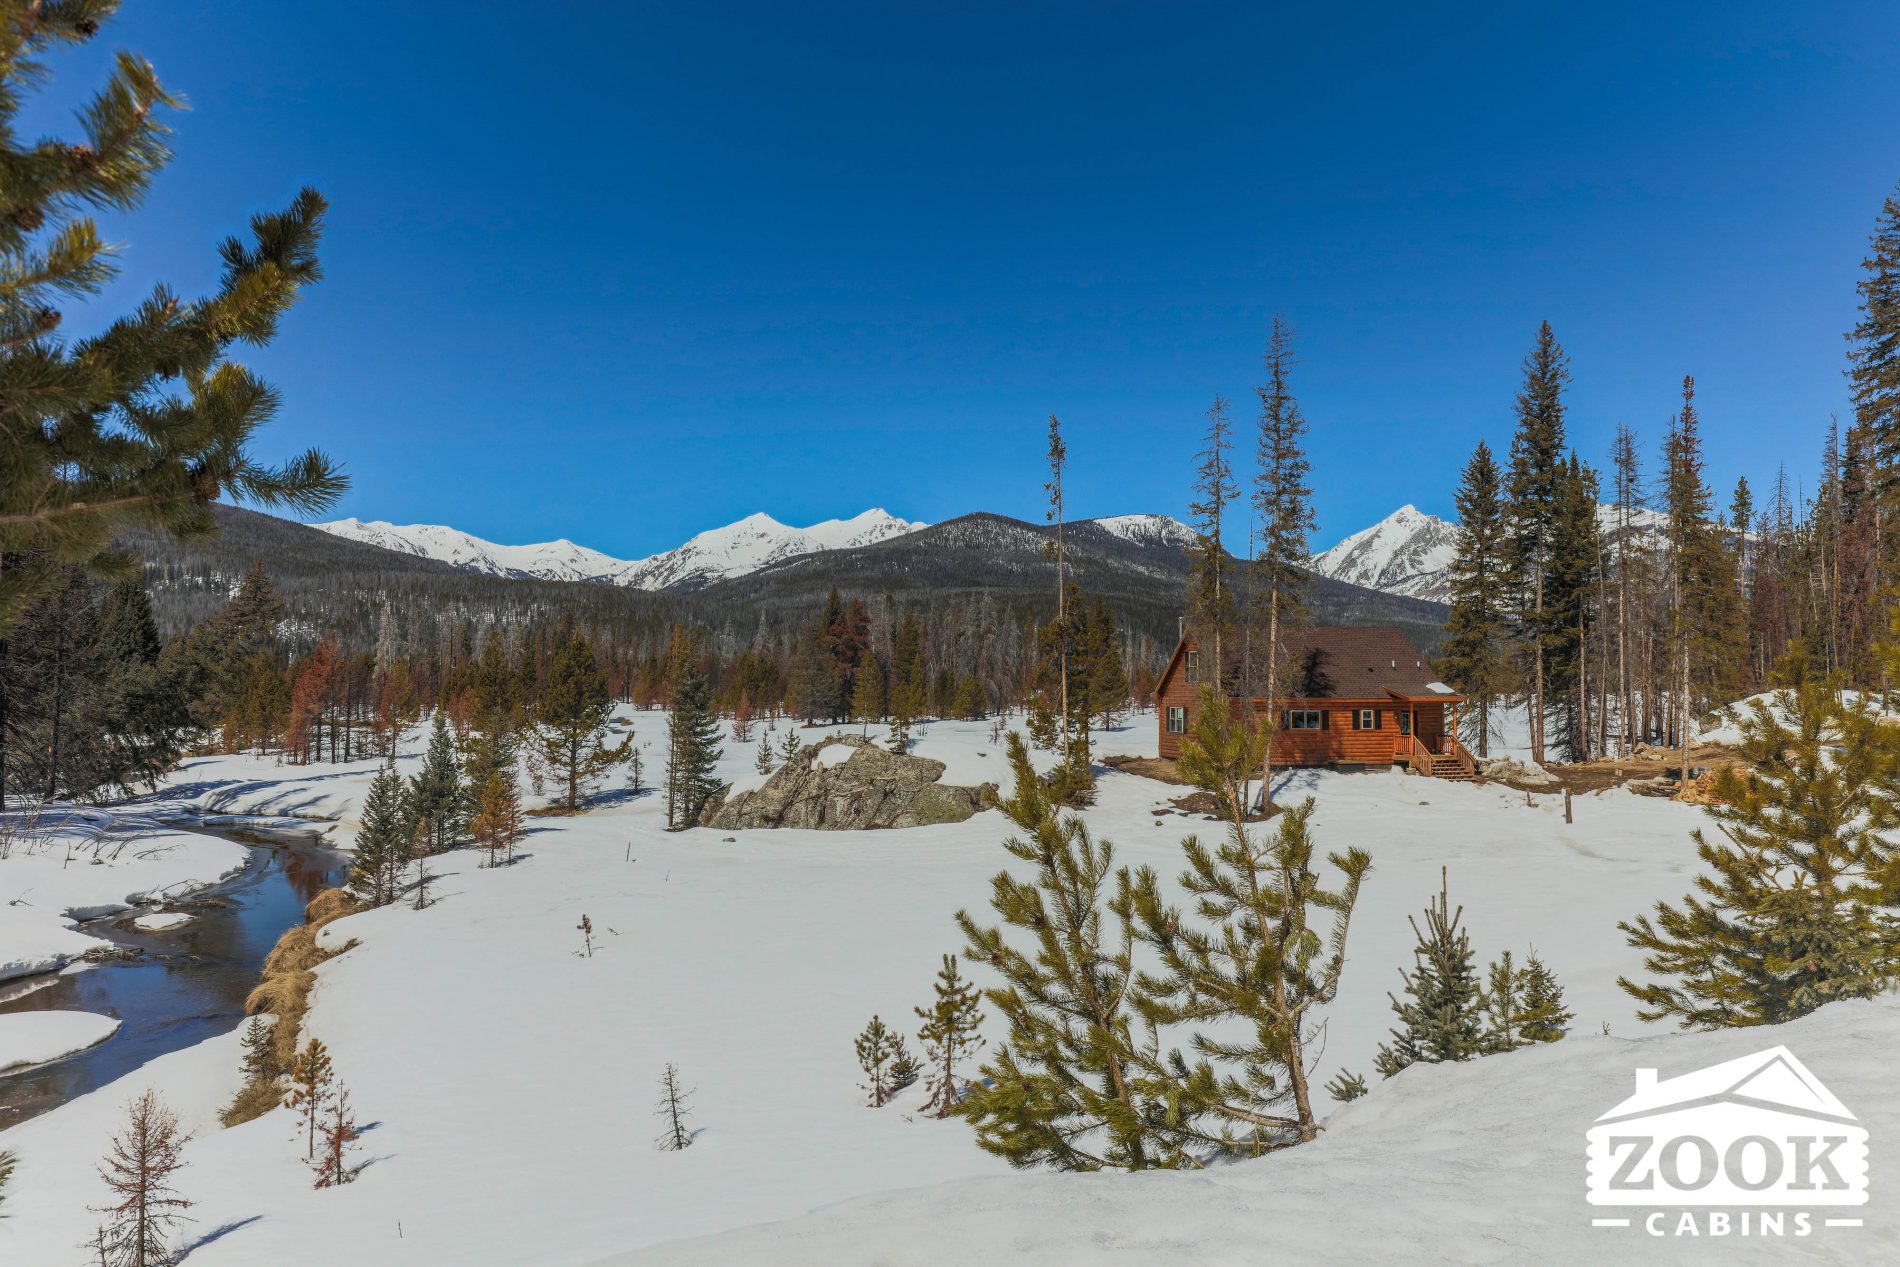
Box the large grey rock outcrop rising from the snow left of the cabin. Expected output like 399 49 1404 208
699 735 996 832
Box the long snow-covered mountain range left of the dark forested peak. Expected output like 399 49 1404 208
312 509 925 589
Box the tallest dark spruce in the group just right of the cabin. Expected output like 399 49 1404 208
1507 321 1569 764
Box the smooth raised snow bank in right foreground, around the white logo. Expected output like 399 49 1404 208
634 999 1900 1267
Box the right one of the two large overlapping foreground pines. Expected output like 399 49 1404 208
1131 688 1372 1155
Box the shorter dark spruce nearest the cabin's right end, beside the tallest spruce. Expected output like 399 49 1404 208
1438 441 1512 756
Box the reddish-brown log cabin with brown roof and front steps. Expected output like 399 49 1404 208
1155 627 1476 779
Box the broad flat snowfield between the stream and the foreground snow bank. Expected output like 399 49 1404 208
0 712 1801 1267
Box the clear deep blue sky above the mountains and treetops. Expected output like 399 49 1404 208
44 0 1900 557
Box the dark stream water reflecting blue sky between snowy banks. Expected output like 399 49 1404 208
0 832 350 1130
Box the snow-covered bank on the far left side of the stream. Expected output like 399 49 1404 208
0 804 249 980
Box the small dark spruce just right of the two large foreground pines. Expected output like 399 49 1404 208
1374 874 1486 1077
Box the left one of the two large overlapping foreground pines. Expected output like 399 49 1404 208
958 733 1153 1170
